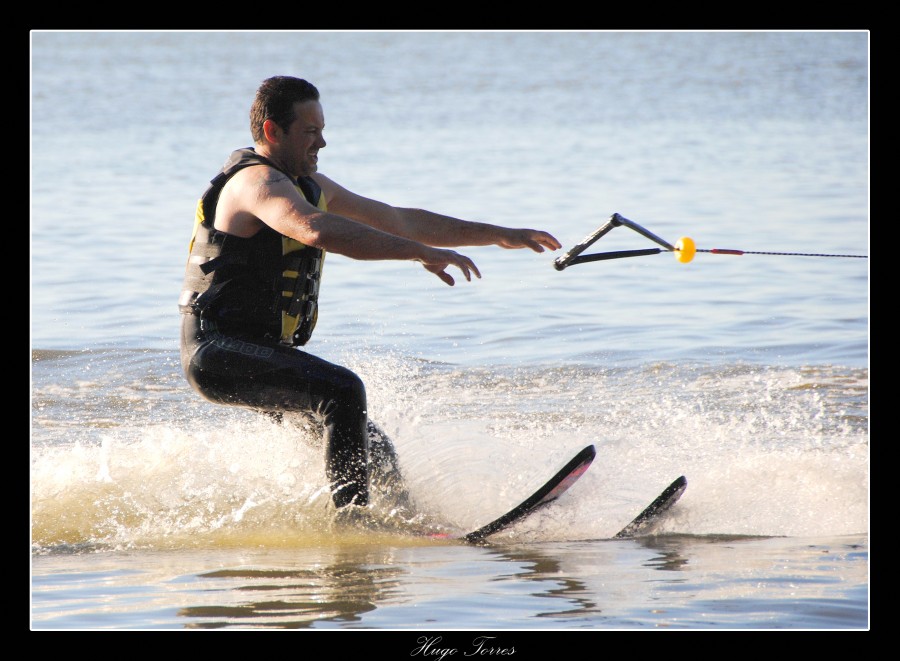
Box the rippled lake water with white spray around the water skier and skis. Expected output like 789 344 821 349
29 31 870 636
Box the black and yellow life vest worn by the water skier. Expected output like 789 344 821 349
178 148 326 346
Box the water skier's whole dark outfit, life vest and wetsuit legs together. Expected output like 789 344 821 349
179 149 399 507
